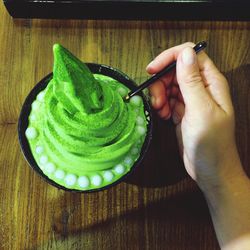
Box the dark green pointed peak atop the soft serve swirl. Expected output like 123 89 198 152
53 44 103 114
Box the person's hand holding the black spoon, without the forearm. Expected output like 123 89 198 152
147 43 242 189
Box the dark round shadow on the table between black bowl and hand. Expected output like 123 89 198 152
124 111 187 187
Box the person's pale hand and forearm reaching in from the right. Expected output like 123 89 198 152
146 43 250 250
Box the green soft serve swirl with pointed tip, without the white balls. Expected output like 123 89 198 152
25 45 146 190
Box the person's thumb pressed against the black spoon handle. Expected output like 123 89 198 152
176 47 209 110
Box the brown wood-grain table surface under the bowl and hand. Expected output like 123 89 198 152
0 2 250 250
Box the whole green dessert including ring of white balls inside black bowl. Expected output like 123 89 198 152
25 44 147 190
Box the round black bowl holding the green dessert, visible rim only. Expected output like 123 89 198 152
18 63 153 192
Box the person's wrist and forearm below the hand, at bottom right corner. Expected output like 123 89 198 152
201 163 250 249
